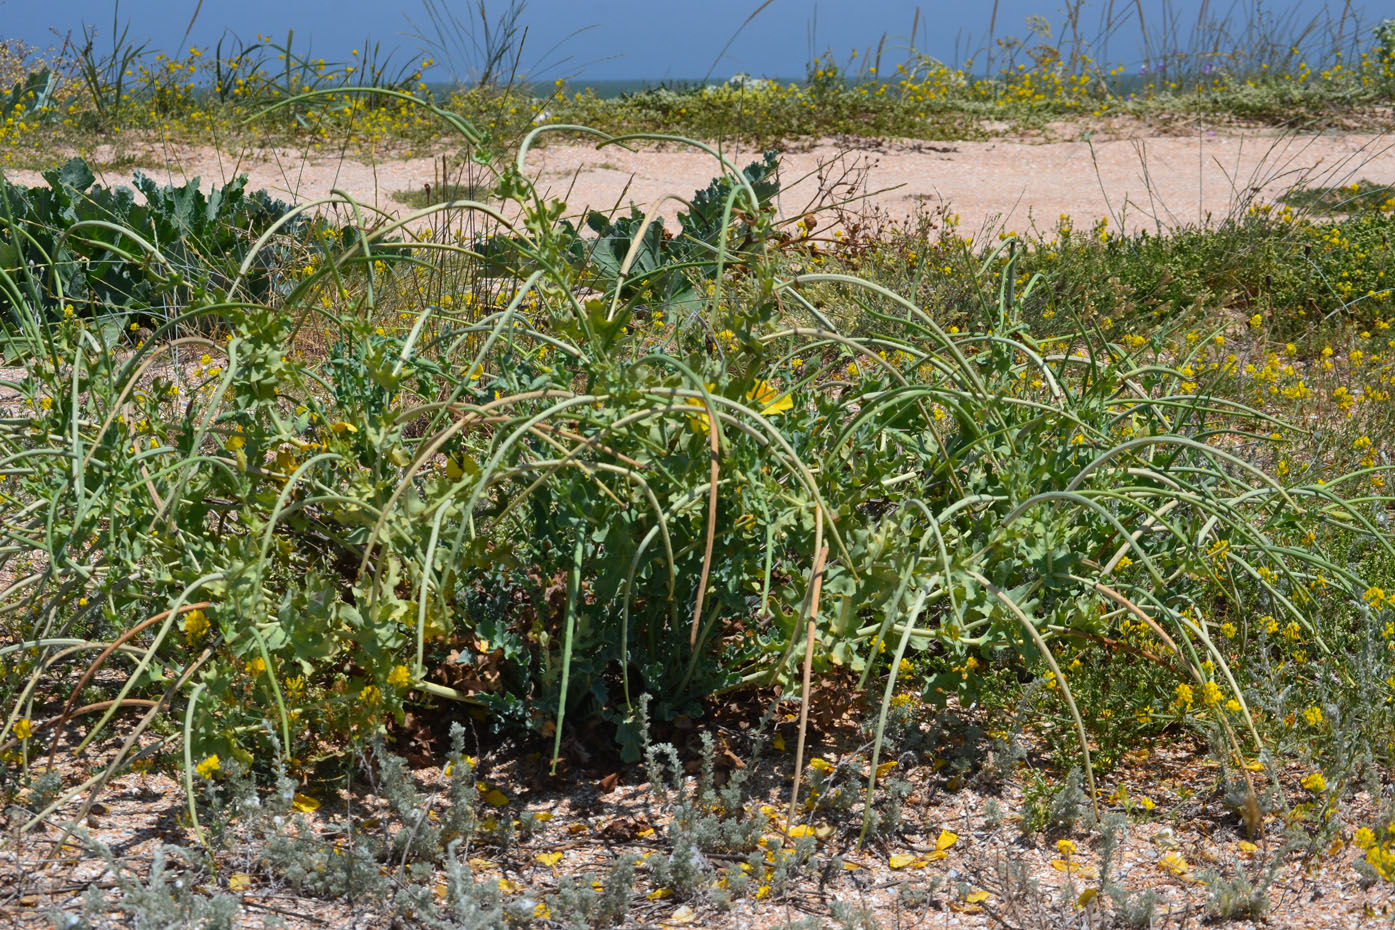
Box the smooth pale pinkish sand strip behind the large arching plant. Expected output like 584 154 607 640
8 127 1395 231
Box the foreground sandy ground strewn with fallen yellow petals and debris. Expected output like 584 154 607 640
0 747 1392 930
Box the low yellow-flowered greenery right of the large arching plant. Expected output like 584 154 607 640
809 195 1395 785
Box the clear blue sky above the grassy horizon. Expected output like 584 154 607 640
0 0 1372 79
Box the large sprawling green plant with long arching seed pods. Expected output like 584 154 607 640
0 89 1389 858
